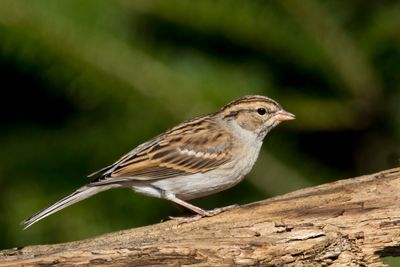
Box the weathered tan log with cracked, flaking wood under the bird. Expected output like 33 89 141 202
0 168 400 266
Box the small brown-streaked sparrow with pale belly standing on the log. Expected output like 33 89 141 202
21 95 295 229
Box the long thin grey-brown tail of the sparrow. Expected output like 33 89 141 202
21 185 116 230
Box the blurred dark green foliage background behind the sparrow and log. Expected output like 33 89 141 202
0 0 400 262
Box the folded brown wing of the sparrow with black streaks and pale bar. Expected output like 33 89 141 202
89 117 233 184
